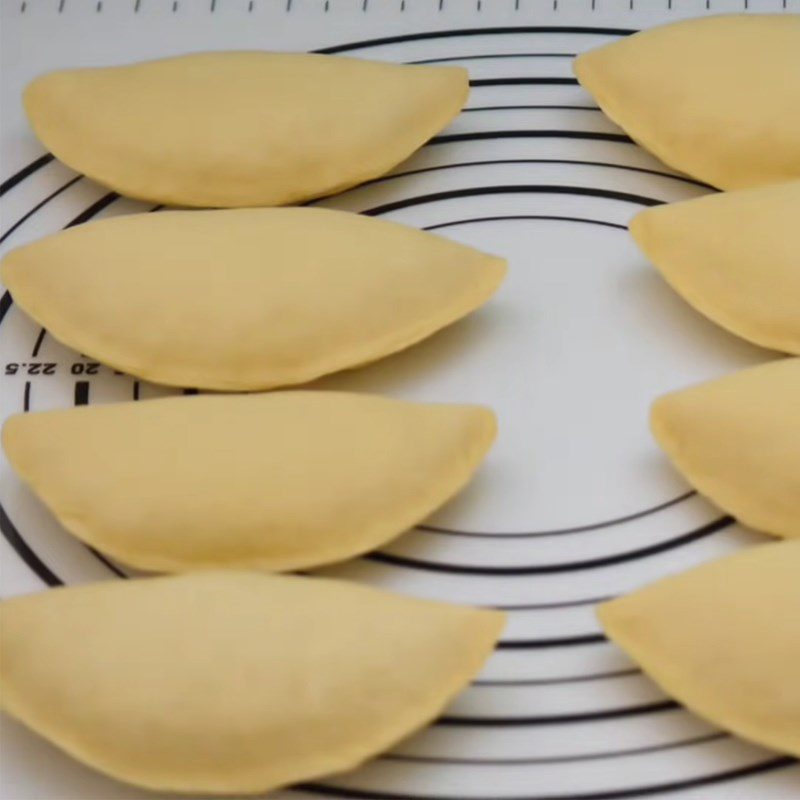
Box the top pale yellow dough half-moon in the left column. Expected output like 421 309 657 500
24 51 469 207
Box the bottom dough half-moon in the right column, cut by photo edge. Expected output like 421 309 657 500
598 541 800 756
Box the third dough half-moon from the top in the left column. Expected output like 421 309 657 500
3 391 496 572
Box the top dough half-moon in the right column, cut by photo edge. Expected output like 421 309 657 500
574 14 800 189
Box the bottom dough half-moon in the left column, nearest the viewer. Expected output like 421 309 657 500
0 572 504 795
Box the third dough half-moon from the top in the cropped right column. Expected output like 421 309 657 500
651 358 800 536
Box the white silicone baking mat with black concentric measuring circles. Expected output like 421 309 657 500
0 0 800 800
